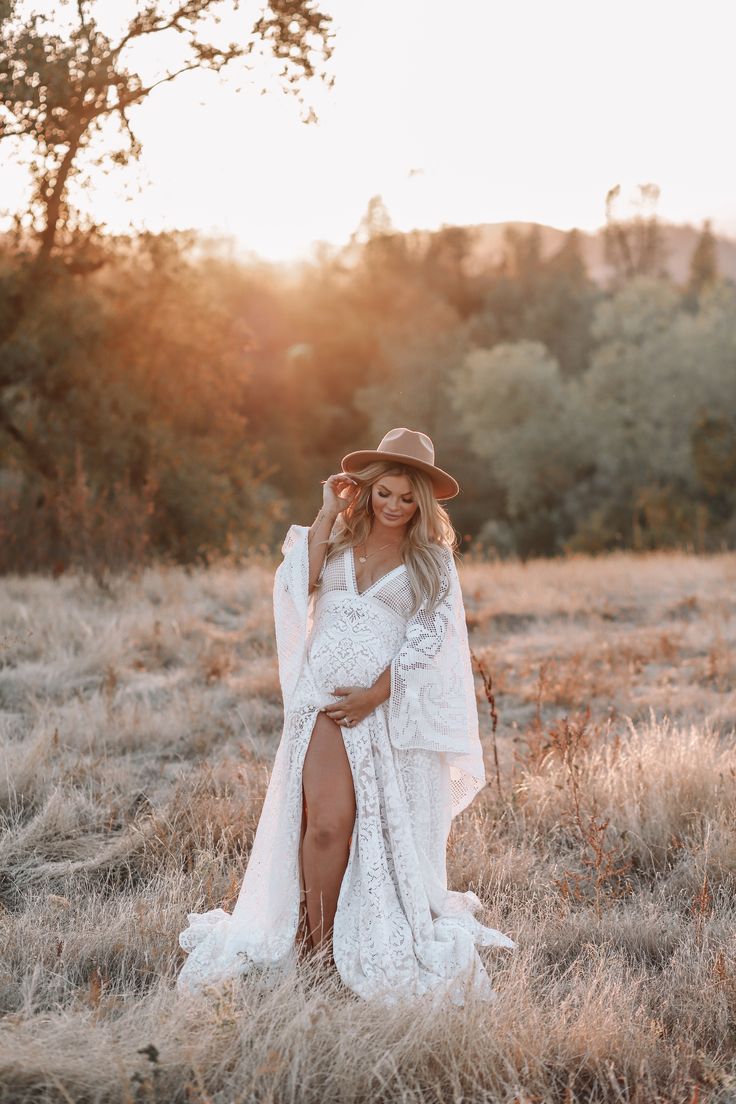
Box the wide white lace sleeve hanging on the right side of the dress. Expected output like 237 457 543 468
386 549 486 816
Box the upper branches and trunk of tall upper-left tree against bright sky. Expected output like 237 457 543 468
0 0 331 269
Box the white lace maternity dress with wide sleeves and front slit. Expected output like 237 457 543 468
177 526 515 1004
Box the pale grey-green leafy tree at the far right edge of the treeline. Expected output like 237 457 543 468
578 276 736 548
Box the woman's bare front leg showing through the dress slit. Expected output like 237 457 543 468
301 713 355 947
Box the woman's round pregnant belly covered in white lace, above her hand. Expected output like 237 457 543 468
307 594 404 693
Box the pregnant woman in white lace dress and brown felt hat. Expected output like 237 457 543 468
177 427 515 1002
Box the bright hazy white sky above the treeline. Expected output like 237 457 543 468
0 0 736 258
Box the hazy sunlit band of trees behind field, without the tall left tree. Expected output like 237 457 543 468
0 207 736 570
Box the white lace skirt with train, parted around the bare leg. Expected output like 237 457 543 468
177 708 515 1004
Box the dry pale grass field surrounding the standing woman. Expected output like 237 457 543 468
0 553 736 1104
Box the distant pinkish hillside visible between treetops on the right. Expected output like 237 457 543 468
465 222 736 285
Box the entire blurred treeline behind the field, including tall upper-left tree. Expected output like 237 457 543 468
0 0 736 571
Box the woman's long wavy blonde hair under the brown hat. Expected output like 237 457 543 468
326 460 458 616
